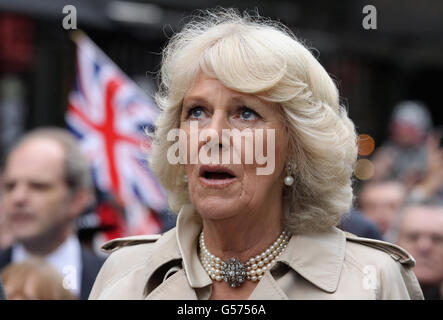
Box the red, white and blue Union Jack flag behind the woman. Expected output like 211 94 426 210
66 34 168 239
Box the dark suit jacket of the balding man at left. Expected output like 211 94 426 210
0 247 105 300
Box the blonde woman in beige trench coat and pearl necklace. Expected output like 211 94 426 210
90 10 422 299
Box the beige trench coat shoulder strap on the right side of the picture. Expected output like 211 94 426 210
345 232 415 268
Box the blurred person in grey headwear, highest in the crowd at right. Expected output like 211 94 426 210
372 100 432 190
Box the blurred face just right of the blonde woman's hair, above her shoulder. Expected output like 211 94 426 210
358 180 407 238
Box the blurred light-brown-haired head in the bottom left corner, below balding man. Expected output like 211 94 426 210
1 258 77 300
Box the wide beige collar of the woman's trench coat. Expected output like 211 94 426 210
147 205 346 299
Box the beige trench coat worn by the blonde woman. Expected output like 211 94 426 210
89 206 423 300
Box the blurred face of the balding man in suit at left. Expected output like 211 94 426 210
3 138 71 243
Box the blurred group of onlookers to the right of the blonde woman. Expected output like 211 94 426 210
341 101 443 299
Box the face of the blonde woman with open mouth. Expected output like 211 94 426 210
180 73 288 219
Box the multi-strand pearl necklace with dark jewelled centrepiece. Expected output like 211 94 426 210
200 231 291 288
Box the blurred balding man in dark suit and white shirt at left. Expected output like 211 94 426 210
0 128 104 299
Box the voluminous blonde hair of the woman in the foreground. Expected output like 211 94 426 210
150 9 357 233
